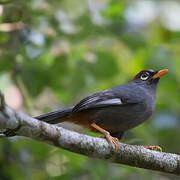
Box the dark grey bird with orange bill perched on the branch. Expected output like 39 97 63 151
35 69 168 149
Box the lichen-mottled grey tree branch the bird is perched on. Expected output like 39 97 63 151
0 94 180 175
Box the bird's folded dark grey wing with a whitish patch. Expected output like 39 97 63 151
72 89 123 112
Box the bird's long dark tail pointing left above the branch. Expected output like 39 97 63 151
34 108 73 124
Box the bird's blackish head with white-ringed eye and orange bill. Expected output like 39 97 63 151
133 69 168 84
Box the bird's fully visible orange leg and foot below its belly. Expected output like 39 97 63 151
91 123 119 151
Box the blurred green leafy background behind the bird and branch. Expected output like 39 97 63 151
0 0 180 180
